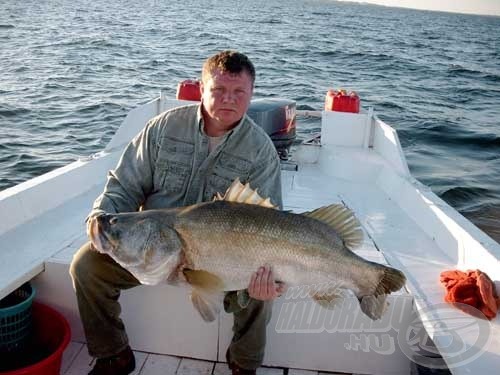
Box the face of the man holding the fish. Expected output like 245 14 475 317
201 70 253 135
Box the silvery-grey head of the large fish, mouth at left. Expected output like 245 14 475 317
89 211 181 285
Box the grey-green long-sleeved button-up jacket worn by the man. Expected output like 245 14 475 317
89 104 282 217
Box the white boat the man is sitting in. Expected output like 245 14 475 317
0 95 500 374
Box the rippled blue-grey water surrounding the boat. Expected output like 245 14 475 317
0 0 500 239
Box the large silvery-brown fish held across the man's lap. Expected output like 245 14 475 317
89 180 406 321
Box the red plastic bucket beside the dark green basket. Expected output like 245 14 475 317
0 302 71 375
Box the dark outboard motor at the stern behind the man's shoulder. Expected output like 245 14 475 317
247 99 296 160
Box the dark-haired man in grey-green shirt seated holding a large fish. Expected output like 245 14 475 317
70 51 282 375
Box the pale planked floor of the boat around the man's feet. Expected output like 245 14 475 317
61 342 355 375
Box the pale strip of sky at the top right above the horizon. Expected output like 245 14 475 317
338 0 500 16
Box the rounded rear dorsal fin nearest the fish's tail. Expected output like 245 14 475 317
302 204 363 250
